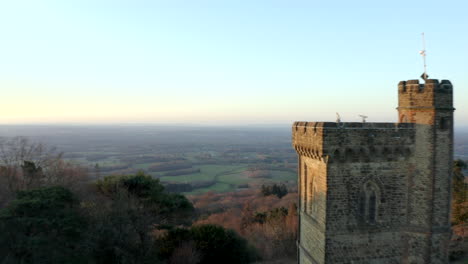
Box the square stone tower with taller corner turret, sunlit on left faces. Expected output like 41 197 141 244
293 80 454 264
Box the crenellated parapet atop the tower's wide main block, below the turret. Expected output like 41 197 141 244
293 122 415 163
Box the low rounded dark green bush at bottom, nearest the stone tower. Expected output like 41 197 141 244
159 225 258 264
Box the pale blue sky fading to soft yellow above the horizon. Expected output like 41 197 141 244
0 0 468 125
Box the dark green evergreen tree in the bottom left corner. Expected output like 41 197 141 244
0 187 87 263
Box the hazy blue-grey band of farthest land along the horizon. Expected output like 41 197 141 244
0 124 468 159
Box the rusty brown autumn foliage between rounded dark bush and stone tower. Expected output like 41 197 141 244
192 189 297 260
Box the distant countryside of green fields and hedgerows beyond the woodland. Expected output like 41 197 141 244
0 126 297 195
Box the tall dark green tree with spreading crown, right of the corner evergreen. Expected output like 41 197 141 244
87 172 193 264
